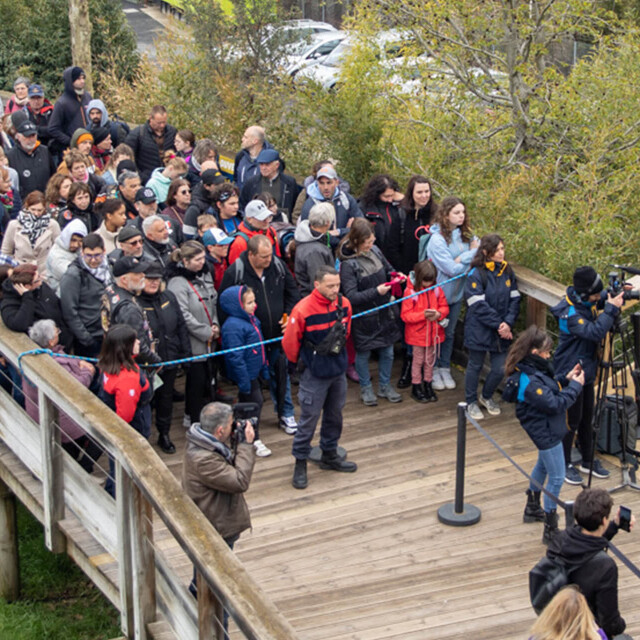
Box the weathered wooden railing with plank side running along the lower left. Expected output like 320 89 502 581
0 325 296 640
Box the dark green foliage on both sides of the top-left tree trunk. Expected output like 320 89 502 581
0 0 138 95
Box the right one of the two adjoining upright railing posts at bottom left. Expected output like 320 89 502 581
129 484 156 640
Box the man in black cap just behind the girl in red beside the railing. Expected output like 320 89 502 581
101 256 160 366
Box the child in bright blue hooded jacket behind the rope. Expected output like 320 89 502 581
220 286 271 458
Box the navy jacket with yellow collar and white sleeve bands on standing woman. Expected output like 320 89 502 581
464 262 520 351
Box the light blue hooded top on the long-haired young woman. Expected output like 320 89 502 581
427 224 476 305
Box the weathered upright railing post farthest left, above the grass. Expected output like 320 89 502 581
38 389 67 553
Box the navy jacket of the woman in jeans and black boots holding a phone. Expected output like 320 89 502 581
502 356 582 450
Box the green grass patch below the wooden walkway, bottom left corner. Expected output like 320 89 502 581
0 503 121 640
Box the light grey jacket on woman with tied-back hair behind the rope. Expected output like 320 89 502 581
167 262 219 356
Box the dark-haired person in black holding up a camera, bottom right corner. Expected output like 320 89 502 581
547 489 636 638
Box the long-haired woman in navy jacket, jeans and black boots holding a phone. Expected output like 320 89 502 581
502 325 585 544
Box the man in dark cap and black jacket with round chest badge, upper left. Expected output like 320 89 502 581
7 116 56 200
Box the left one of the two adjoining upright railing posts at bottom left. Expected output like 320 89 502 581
115 459 135 638
